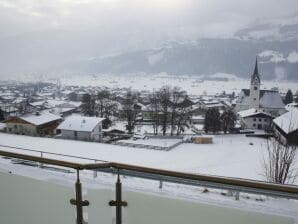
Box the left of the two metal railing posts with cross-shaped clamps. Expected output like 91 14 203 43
70 170 89 224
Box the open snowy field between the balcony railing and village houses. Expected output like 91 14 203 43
0 133 292 180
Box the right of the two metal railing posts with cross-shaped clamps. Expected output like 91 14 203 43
109 170 127 224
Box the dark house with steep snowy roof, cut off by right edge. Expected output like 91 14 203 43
273 108 298 145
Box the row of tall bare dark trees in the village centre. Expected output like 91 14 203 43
82 86 191 135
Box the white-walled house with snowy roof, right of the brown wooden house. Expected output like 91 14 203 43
57 115 105 142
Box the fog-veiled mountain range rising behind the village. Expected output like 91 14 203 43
0 13 298 81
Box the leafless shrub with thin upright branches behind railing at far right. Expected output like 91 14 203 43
263 138 296 184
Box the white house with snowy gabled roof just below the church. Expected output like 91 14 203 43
238 108 273 130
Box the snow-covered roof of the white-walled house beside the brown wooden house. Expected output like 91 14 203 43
57 115 105 132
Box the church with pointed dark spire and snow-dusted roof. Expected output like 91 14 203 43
235 59 285 117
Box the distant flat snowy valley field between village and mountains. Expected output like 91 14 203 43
61 74 298 95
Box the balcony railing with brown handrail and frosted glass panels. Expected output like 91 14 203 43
0 147 298 224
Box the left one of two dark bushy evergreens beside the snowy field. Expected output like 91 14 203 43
204 108 221 133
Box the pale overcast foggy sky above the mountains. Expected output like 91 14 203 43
0 0 298 79
